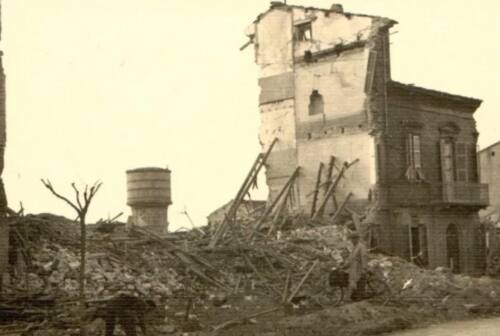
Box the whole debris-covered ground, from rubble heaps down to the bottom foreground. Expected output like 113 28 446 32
0 214 500 336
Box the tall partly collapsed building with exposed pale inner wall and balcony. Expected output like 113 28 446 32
247 2 488 273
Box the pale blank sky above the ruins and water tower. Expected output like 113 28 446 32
0 0 500 230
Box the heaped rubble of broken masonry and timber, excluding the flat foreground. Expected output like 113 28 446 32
2 215 500 336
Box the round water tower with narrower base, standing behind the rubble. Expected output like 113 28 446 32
127 168 172 235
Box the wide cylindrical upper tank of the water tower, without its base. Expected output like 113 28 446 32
127 168 172 207
